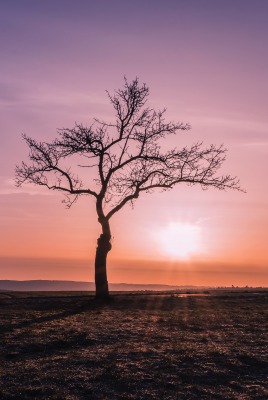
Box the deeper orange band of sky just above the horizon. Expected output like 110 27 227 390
0 257 268 287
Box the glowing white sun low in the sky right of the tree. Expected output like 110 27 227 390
156 222 201 260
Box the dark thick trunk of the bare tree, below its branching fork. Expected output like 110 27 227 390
95 221 112 300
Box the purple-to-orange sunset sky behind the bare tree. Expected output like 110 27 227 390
0 0 268 286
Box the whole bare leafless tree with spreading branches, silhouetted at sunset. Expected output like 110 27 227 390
16 78 241 299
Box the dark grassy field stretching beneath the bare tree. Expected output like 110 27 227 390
0 290 268 400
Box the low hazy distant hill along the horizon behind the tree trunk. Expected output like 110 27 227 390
0 280 196 292
